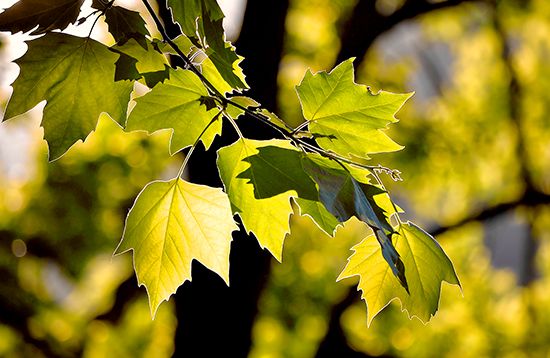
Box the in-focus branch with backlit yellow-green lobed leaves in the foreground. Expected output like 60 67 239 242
0 0 459 322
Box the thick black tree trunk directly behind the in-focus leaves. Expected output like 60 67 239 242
174 0 288 357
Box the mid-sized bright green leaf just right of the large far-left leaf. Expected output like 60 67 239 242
126 69 222 154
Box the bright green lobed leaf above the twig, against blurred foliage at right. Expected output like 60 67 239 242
296 59 412 158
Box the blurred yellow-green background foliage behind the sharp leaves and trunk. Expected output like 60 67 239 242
0 0 550 358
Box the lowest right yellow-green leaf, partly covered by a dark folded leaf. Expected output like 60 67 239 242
338 222 460 325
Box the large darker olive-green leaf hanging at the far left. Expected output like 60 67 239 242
5 33 132 160
